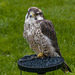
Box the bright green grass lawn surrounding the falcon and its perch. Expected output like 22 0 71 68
0 0 75 75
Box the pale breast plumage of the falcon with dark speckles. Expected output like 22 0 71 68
23 22 47 54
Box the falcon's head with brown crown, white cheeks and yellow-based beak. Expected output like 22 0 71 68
26 7 44 21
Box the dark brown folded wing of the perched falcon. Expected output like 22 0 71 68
40 20 61 56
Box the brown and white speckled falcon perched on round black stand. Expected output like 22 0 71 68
23 7 71 72
